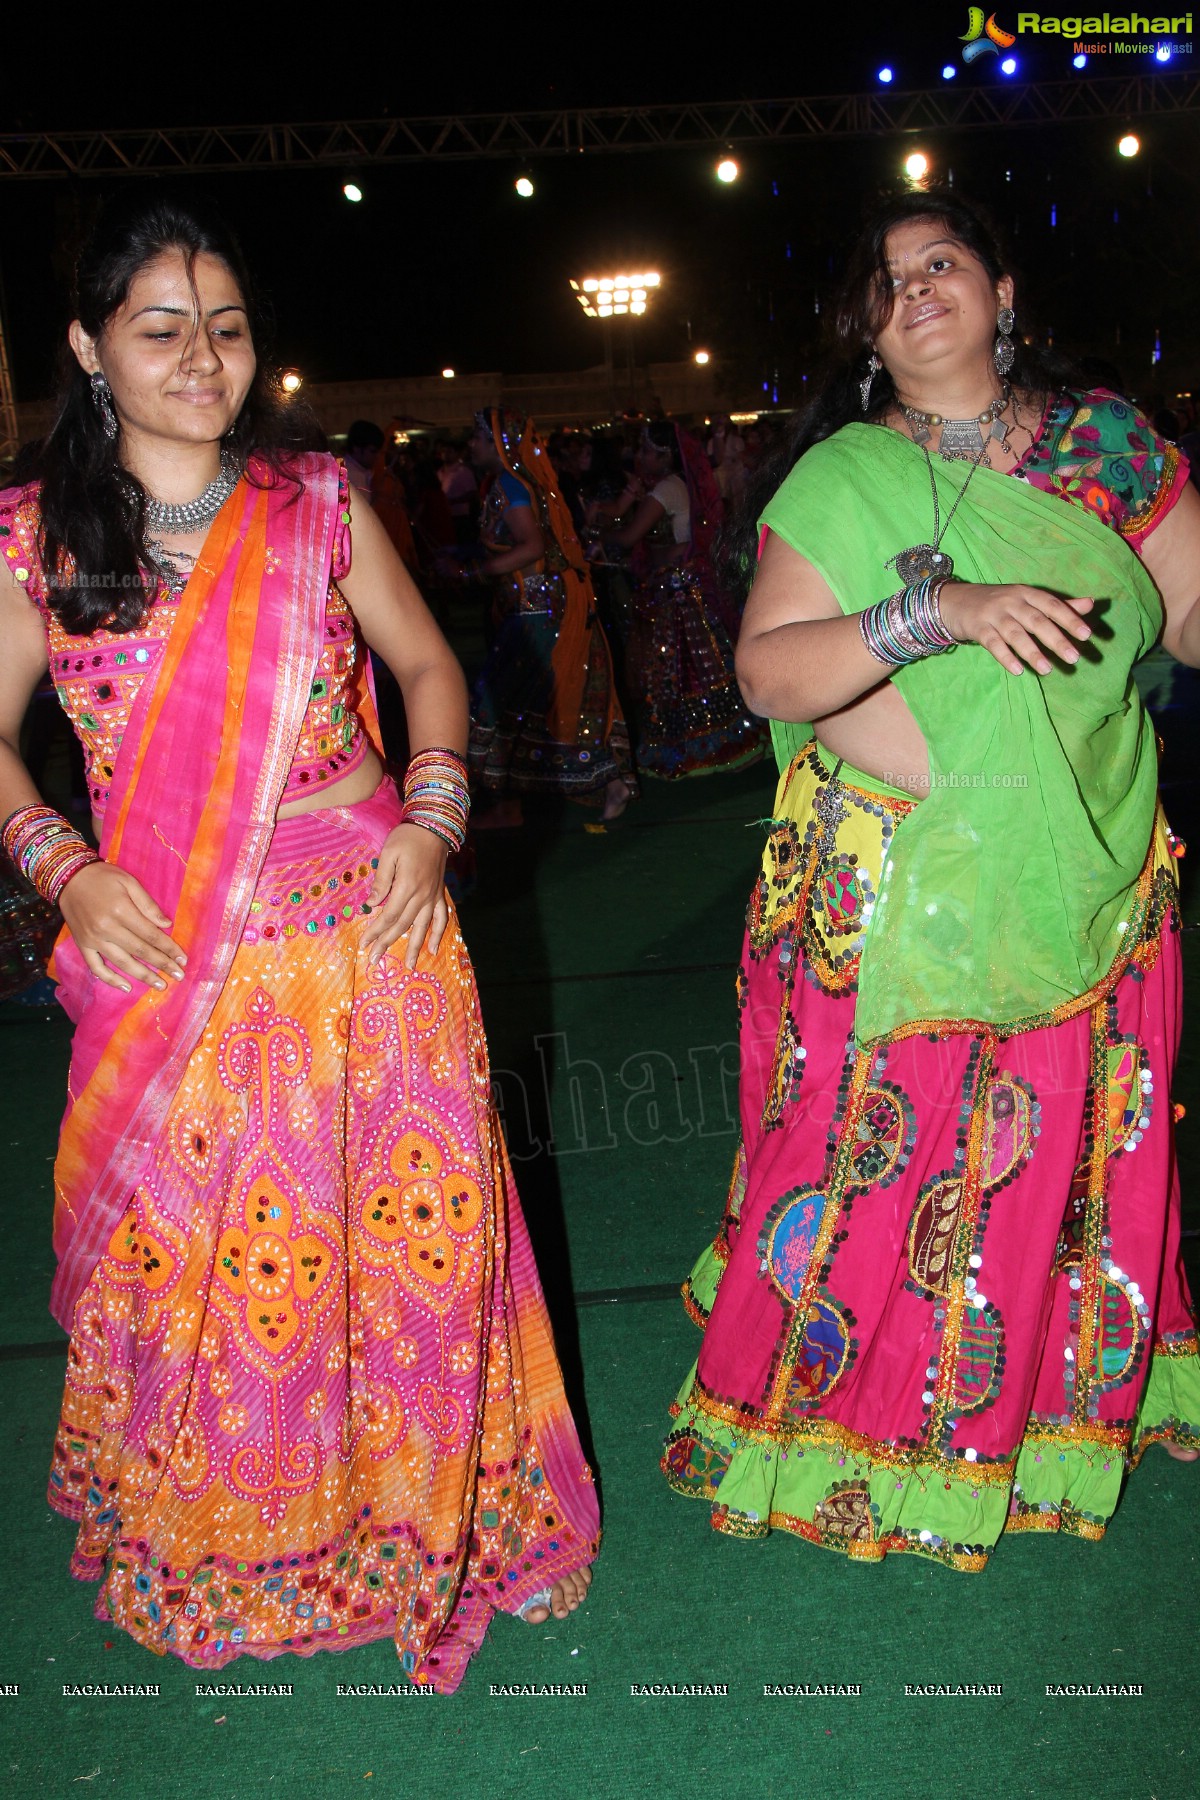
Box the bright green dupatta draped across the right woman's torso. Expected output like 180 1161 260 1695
763 425 1162 1044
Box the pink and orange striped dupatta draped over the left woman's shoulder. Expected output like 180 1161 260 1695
50 455 338 1330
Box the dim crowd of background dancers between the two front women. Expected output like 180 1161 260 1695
323 409 765 830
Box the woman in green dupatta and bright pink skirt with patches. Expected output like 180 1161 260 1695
662 191 1200 1570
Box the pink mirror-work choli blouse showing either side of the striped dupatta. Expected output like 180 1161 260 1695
0 468 367 817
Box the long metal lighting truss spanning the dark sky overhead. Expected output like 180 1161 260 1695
0 72 1200 182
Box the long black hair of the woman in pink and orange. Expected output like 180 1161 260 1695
40 194 313 637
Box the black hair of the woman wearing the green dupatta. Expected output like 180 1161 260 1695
716 187 1078 598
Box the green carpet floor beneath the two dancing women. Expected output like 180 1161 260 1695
0 752 1200 1800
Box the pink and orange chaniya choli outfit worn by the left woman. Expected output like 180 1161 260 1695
0 457 597 1690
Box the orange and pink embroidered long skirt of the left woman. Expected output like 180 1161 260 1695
50 783 597 1692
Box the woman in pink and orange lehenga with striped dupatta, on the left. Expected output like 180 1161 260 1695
0 202 597 1690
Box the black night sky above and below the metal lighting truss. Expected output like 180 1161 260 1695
0 0 1200 400
